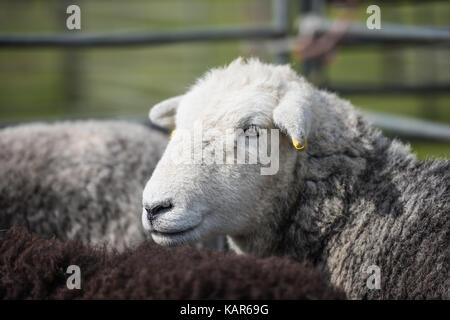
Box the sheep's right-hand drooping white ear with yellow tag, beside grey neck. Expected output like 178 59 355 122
273 81 314 151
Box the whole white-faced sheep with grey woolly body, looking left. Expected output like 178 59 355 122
142 59 450 299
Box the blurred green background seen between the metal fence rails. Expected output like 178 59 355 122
0 0 450 159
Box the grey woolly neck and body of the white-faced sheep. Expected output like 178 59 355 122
231 91 450 299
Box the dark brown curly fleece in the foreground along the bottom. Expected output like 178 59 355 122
0 227 344 299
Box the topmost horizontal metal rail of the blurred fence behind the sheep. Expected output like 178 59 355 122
0 21 450 48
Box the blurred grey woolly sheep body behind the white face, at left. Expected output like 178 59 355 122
0 121 167 250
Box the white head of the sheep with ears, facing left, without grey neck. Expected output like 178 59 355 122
142 59 309 245
